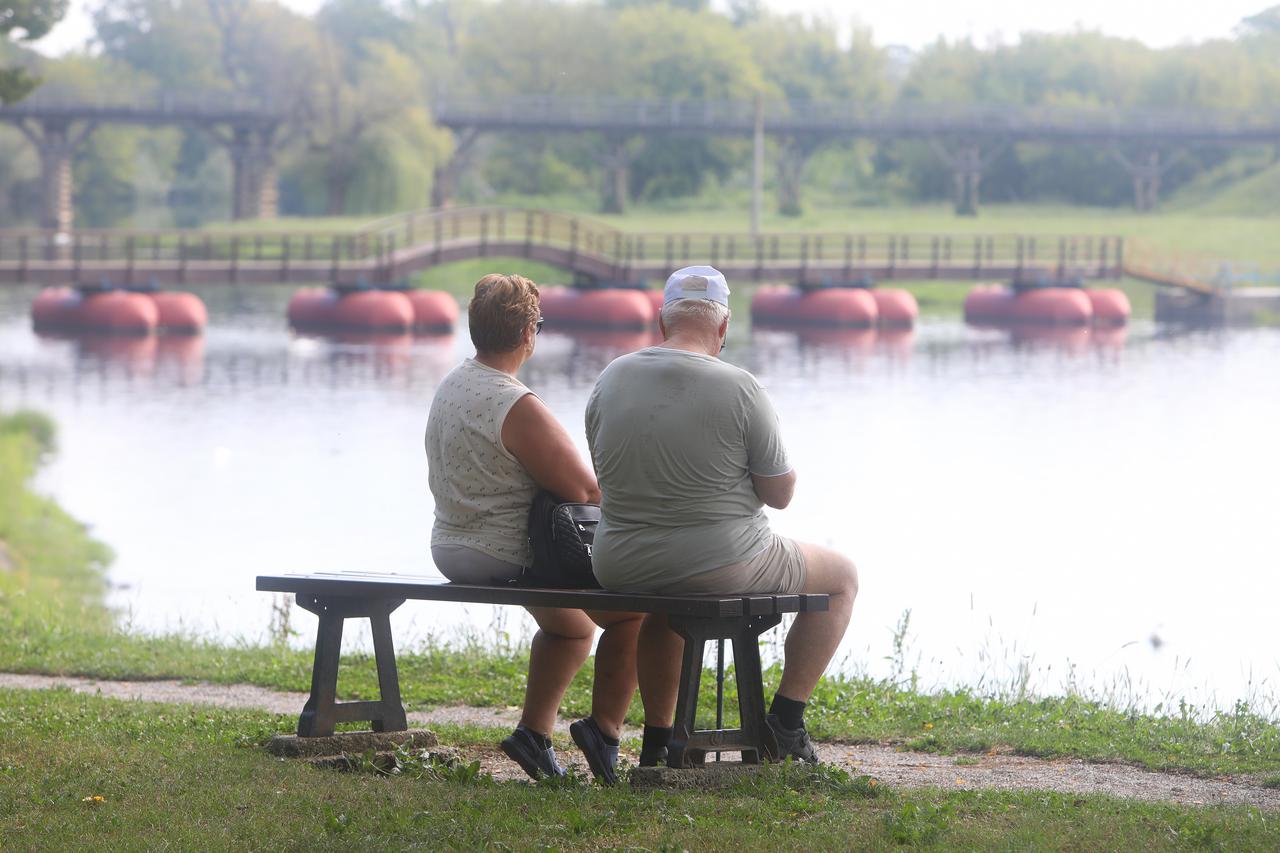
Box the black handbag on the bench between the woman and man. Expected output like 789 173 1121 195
520 489 600 589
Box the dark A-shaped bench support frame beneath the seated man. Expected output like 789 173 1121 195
667 613 782 767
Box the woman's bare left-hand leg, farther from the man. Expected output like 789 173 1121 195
520 607 595 734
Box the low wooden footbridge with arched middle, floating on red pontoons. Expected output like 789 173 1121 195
0 207 1212 292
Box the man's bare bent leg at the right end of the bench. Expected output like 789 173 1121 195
773 542 858 702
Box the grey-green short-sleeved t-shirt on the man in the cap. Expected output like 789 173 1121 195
586 347 791 592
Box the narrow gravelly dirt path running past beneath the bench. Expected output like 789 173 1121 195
0 674 1280 811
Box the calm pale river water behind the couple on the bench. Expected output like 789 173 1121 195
0 287 1280 713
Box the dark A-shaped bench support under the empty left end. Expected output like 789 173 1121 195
297 594 408 738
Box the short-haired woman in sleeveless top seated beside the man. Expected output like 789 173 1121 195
426 274 640 784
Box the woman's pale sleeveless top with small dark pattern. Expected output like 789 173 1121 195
426 359 538 566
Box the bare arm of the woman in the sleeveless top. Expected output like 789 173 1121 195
502 394 600 503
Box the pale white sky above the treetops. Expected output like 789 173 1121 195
27 0 1280 55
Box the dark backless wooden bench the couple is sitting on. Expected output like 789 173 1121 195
257 573 828 767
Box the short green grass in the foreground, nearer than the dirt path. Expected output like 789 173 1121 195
0 690 1280 850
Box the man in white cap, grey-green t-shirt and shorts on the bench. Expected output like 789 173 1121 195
586 266 858 765
